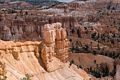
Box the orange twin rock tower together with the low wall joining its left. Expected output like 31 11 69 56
0 23 69 71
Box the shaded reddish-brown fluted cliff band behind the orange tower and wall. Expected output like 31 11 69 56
0 13 78 41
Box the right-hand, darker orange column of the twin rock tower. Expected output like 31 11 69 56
55 25 69 63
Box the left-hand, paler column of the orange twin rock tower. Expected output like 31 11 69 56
41 24 56 71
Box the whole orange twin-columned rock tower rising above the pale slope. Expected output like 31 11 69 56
41 23 69 71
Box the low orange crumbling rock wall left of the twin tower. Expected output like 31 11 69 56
0 41 41 60
